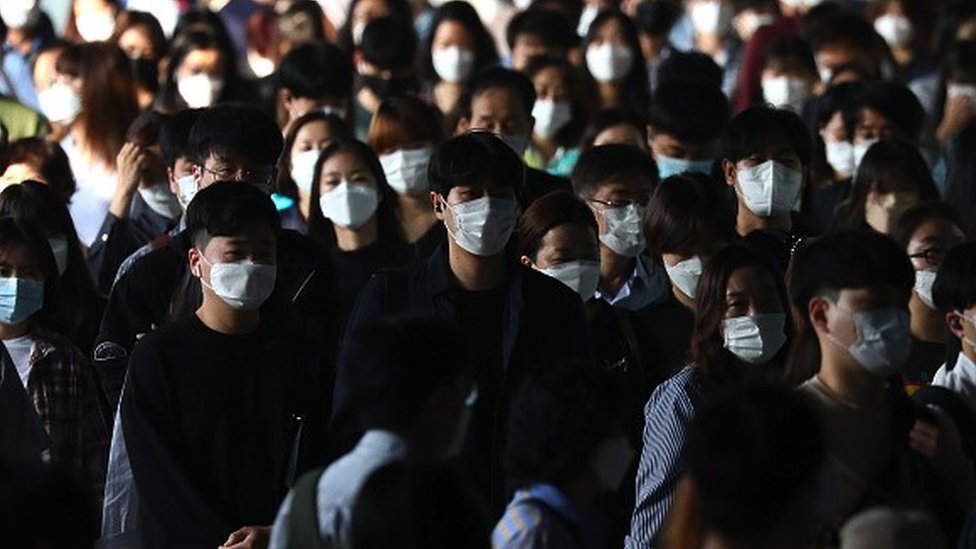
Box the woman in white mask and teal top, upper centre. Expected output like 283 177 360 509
523 57 592 177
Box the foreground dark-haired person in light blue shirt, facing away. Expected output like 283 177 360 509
269 319 478 549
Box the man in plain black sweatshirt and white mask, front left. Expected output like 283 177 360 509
118 182 328 547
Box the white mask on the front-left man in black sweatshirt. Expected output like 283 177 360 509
200 252 277 311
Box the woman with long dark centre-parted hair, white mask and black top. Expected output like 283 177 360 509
308 140 412 326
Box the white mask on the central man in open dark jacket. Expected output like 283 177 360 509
441 196 518 257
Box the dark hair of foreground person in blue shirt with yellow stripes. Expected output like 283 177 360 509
502 361 623 488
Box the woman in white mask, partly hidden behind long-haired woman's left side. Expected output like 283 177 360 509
275 110 351 234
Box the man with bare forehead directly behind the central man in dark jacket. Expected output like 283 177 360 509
455 67 572 208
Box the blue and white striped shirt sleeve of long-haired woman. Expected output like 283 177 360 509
624 366 702 549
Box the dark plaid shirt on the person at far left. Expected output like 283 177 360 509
27 328 110 508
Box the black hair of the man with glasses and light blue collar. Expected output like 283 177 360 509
571 143 658 197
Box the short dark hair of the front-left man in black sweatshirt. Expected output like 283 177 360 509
186 181 281 250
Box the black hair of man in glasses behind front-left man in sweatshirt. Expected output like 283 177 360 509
186 104 284 166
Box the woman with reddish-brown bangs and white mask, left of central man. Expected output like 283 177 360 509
368 97 447 257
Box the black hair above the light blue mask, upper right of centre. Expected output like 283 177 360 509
647 80 729 143
